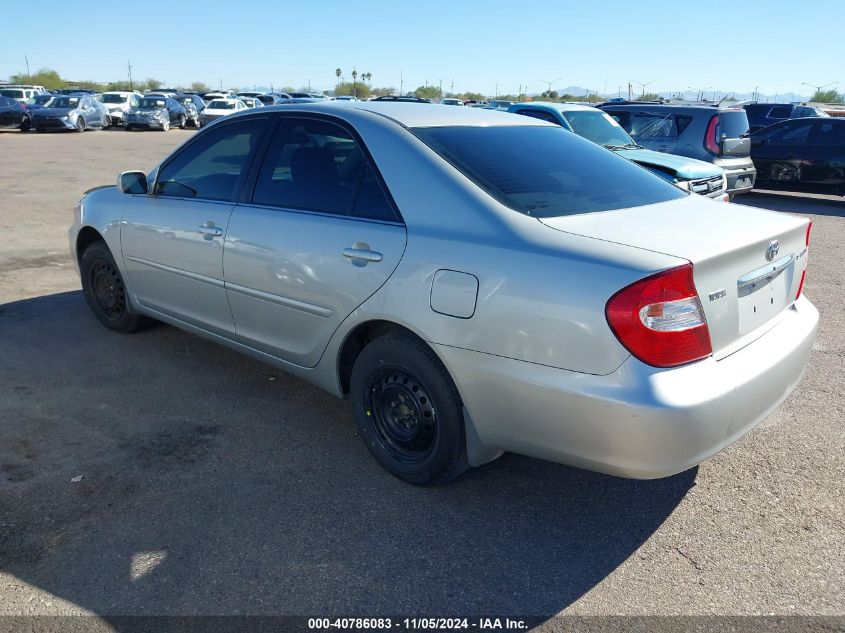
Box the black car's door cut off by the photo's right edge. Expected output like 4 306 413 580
800 118 845 194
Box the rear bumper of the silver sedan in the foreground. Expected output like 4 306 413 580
436 296 818 479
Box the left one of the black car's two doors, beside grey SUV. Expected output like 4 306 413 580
752 119 813 190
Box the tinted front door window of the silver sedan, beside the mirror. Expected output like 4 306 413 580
155 118 267 200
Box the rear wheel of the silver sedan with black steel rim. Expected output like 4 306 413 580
350 333 469 485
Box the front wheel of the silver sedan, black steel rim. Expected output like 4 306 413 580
79 242 151 334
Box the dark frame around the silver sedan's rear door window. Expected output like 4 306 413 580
238 112 405 226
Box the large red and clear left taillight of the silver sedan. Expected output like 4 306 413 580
605 264 713 367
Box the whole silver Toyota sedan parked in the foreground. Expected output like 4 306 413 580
70 102 818 484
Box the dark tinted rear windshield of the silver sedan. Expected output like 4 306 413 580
412 125 688 218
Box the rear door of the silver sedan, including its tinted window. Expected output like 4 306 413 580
223 116 405 367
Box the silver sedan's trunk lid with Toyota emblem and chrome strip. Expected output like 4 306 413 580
540 195 809 359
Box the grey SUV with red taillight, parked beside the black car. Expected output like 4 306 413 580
600 103 757 198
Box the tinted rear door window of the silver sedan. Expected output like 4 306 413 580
252 117 397 220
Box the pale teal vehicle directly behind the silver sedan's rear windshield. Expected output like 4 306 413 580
508 101 727 200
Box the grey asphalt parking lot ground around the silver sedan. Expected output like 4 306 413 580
0 130 845 619
